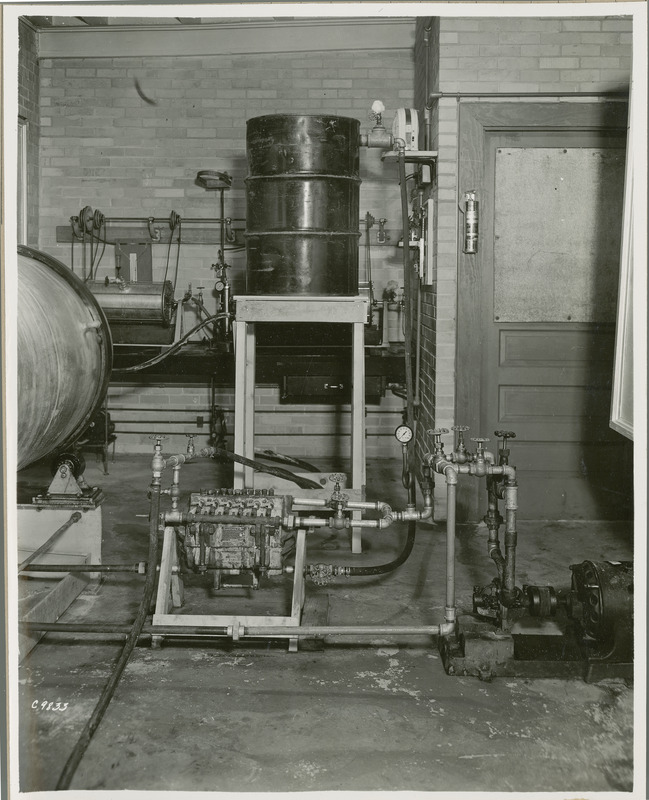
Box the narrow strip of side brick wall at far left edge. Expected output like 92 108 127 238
18 22 40 247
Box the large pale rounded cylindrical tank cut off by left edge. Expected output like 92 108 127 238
17 245 113 469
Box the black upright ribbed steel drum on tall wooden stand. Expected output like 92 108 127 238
246 114 360 296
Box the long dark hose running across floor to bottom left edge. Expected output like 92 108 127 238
56 484 160 791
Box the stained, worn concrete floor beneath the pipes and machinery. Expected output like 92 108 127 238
19 455 633 792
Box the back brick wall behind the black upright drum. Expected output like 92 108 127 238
31 29 414 458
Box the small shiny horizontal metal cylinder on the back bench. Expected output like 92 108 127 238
86 281 174 327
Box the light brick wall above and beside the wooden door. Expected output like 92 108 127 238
415 17 632 517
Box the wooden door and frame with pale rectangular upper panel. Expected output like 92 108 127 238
456 103 632 519
